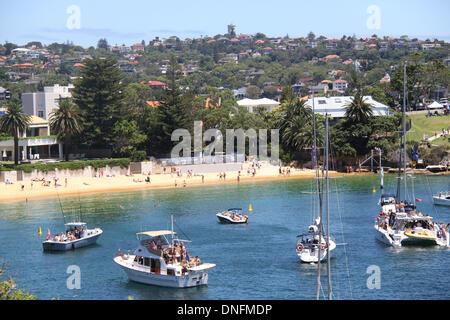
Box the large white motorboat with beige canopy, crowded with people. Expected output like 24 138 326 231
114 218 216 288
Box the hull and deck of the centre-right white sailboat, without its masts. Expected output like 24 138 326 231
297 218 336 263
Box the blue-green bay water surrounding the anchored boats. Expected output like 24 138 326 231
0 175 450 300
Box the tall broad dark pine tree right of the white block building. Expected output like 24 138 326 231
72 58 124 148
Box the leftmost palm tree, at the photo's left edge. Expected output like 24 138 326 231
0 102 31 165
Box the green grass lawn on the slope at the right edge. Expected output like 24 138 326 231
407 114 450 145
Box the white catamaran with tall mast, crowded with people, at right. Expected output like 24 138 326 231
374 62 449 248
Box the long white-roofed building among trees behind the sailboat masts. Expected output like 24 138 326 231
306 96 391 118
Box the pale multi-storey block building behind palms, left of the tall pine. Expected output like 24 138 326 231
22 84 73 120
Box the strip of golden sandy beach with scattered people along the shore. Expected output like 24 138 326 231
0 166 352 202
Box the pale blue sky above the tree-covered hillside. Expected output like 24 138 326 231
0 0 450 47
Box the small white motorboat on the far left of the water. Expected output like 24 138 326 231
42 222 103 251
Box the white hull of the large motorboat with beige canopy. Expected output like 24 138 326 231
114 256 208 288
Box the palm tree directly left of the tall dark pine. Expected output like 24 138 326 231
50 99 83 161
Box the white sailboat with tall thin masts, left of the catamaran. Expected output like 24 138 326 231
296 107 336 263
